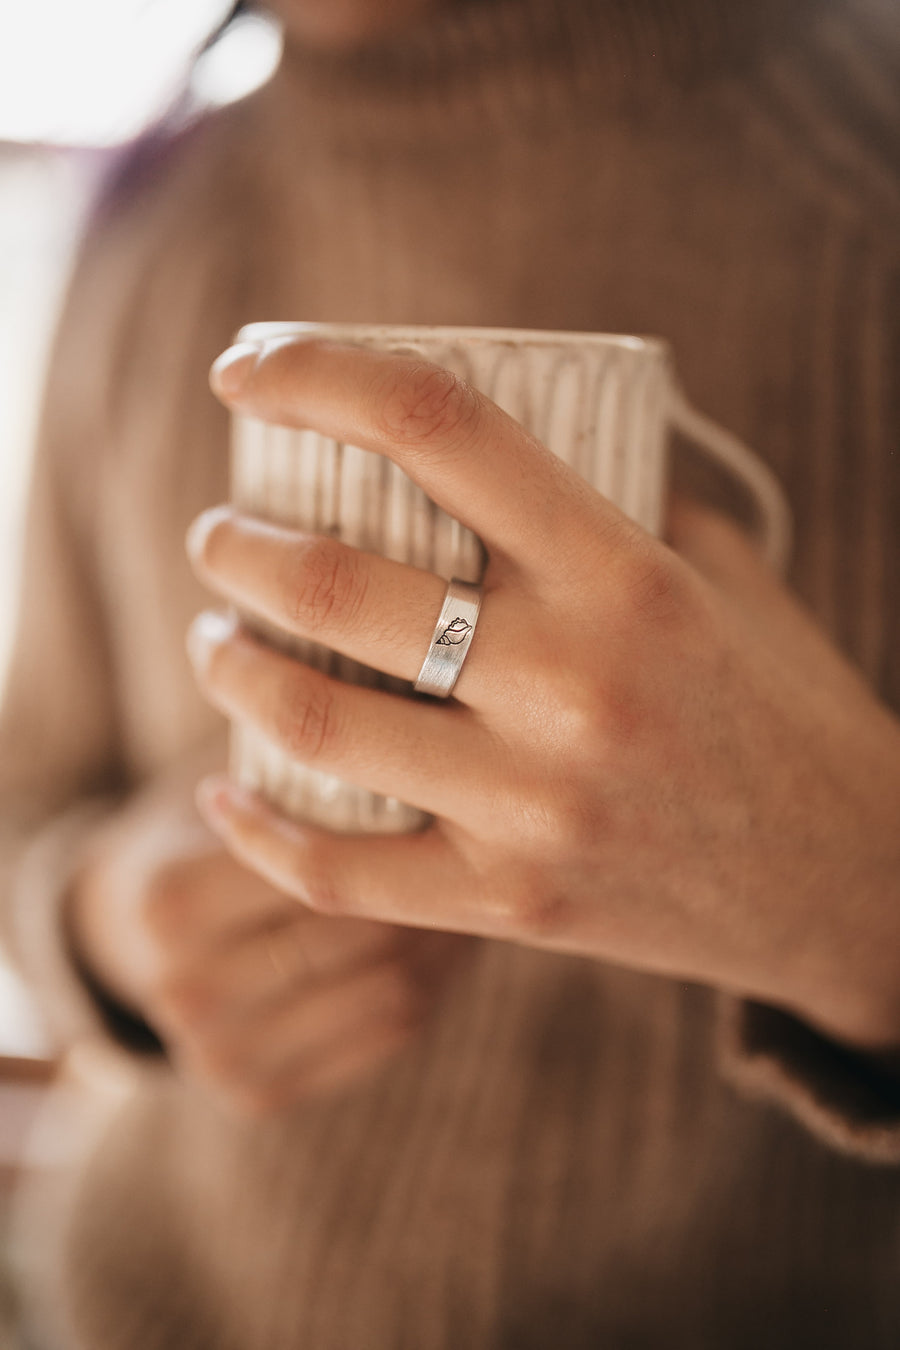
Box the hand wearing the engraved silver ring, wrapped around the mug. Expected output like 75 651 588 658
189 339 900 1048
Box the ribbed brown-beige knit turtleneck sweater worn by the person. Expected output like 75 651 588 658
0 0 900 1350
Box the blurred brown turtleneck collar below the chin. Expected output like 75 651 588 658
244 0 820 146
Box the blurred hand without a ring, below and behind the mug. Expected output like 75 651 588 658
67 774 472 1114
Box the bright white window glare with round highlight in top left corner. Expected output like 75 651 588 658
0 0 281 146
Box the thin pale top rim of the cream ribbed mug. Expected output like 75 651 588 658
232 320 672 358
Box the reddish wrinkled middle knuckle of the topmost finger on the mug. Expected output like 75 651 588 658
381 363 479 446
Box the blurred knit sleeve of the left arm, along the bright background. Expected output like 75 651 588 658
0 202 159 1052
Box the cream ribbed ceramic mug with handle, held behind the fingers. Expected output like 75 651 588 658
229 323 791 833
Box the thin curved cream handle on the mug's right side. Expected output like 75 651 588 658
669 383 793 576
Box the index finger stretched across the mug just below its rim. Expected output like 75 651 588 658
210 338 629 576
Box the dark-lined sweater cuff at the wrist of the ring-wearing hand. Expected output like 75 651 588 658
718 994 900 1164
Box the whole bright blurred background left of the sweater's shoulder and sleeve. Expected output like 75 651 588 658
0 0 281 1274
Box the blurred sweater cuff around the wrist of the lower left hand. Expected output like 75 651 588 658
9 794 163 1068
